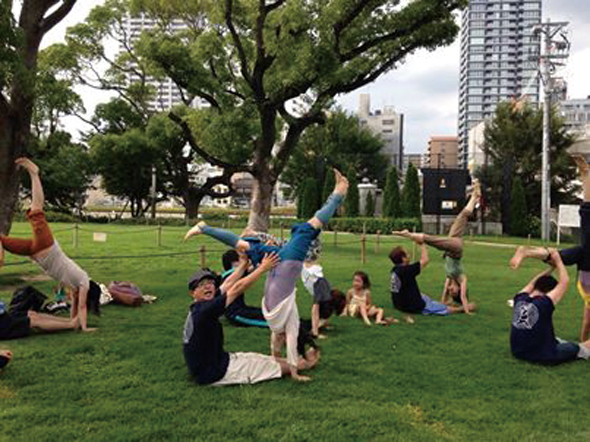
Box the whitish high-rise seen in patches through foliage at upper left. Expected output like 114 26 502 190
119 13 206 111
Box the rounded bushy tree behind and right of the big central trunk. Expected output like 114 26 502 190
281 109 387 203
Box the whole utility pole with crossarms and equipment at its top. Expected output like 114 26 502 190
531 19 570 241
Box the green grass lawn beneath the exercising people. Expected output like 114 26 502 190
0 224 590 441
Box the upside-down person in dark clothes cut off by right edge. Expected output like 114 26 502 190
510 156 590 341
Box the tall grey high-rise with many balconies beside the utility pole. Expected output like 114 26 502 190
458 0 541 168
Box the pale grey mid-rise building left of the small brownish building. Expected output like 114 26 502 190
358 94 404 170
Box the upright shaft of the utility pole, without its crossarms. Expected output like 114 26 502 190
541 20 551 241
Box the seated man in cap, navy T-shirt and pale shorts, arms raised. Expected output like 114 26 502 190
183 254 319 386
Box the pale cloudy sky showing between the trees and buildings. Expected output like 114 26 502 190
43 0 590 153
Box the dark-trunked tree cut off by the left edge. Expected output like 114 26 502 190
0 0 76 233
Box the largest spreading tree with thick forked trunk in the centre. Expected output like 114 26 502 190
60 0 467 230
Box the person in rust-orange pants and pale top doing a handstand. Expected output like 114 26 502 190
0 158 100 331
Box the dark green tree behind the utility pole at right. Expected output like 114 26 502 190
478 102 579 232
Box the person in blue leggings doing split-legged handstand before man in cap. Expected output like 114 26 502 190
185 170 348 381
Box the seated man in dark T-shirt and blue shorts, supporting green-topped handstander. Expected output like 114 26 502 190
389 234 475 316
